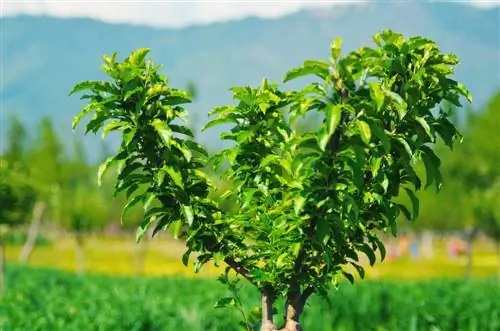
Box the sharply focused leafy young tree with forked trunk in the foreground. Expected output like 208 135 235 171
70 30 471 331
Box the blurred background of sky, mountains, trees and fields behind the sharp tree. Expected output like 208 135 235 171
0 0 500 330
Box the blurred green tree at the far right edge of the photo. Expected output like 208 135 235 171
450 92 500 276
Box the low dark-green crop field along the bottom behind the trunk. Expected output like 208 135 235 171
0 266 500 331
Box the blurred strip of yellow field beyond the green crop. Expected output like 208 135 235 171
6 233 498 280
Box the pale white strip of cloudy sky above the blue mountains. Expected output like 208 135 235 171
1 0 500 26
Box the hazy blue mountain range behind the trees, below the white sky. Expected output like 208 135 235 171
1 1 500 158
